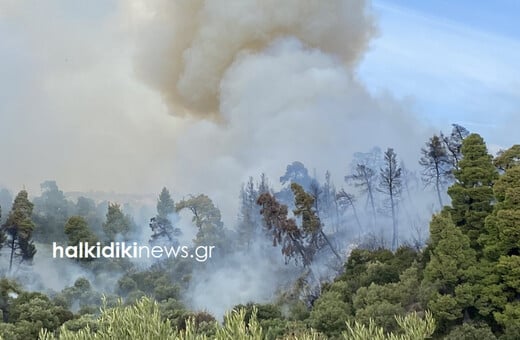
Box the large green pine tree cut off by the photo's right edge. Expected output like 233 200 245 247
474 165 520 338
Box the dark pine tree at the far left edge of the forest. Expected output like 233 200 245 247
3 190 36 271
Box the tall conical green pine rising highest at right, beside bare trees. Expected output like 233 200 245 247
448 134 498 250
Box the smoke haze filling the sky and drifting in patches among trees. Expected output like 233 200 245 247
0 0 508 322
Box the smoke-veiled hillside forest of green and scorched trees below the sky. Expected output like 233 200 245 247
0 125 520 340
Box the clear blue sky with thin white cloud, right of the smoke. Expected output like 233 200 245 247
360 0 520 146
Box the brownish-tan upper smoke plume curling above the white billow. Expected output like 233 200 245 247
134 0 375 117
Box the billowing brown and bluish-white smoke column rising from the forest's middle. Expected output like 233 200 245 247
128 0 424 315
